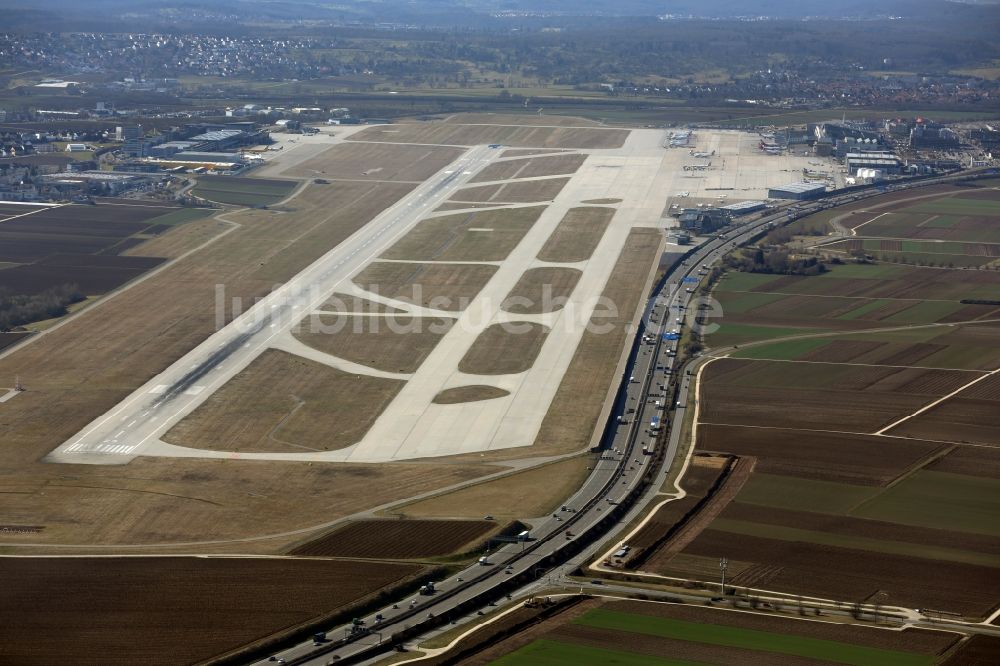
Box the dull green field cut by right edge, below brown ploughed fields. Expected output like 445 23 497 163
850 470 1000 536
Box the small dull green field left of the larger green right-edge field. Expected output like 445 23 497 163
737 472 886 520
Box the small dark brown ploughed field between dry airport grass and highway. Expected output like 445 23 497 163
292 520 499 560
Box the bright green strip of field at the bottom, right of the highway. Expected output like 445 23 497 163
575 608 934 666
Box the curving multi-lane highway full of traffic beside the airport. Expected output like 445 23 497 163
244 165 1000 666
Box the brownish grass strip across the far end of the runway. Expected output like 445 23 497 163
351 123 628 148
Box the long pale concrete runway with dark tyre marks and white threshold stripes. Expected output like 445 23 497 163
46 146 500 464
